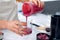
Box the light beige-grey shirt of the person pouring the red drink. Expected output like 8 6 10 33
0 0 18 20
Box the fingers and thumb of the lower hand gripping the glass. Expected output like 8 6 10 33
12 21 27 36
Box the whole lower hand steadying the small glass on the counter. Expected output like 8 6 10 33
6 21 26 35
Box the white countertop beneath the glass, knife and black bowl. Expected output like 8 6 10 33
3 12 50 40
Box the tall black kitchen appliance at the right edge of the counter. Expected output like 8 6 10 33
50 14 60 40
